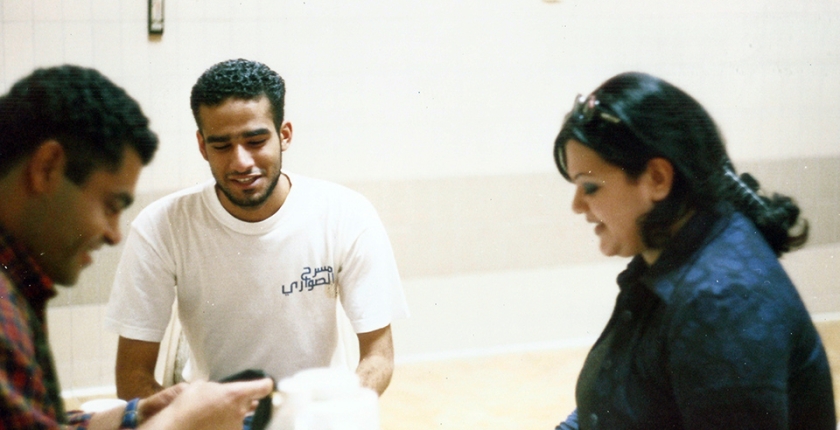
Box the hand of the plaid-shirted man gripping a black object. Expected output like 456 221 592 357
138 378 274 430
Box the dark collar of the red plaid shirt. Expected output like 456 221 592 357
0 225 57 321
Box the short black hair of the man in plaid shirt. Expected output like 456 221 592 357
0 65 158 185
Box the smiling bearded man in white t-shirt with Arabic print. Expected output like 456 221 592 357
106 59 408 398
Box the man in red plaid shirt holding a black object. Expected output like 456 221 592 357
0 66 272 429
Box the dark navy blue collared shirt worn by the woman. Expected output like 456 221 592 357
557 208 837 430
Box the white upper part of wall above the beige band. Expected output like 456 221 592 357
0 0 840 191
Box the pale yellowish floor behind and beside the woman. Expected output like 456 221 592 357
380 322 840 430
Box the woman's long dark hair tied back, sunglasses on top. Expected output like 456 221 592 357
554 73 808 255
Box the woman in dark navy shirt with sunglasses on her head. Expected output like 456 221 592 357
554 73 836 430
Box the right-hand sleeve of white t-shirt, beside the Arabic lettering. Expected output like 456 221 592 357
337 201 408 333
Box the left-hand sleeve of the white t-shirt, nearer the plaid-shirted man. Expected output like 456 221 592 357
105 209 176 342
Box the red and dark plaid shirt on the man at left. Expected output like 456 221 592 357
0 226 91 429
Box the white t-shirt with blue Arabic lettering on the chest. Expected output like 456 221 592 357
105 172 408 380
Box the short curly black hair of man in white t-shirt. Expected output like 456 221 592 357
190 58 286 130
